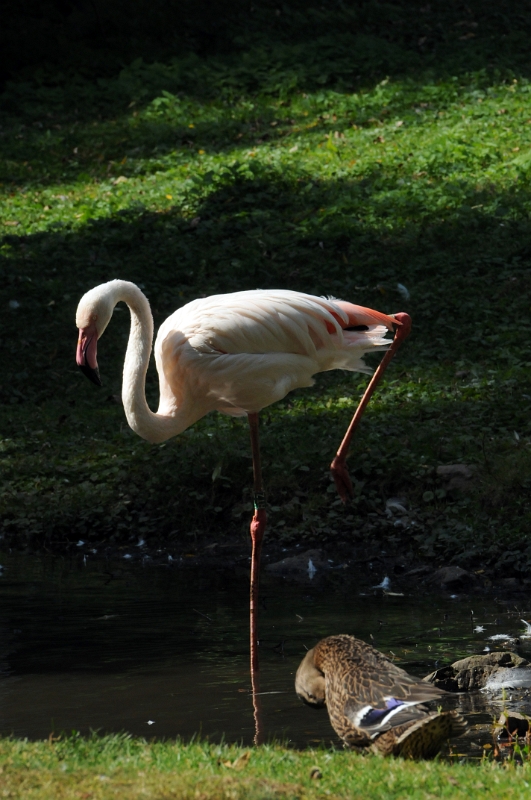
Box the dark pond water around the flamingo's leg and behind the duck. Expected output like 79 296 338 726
0 553 531 754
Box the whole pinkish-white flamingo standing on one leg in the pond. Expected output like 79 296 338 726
76 280 410 736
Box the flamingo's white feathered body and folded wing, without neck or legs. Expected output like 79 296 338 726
155 290 389 414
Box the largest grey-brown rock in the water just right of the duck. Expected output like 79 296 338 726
424 652 531 692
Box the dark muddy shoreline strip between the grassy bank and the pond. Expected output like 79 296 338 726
15 535 531 604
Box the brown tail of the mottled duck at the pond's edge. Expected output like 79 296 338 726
373 711 467 759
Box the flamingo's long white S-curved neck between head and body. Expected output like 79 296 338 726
113 281 197 443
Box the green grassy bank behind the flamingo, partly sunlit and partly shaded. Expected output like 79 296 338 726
0 3 531 575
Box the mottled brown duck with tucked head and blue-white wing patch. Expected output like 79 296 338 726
295 634 467 759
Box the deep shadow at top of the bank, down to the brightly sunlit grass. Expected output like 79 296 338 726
0 0 531 126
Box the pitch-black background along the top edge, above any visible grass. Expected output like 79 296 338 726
0 0 531 91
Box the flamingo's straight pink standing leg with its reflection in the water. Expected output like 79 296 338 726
248 413 266 744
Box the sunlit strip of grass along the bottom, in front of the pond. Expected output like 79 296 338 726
0 734 531 800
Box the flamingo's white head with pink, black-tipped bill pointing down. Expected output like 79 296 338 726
76 284 114 386
